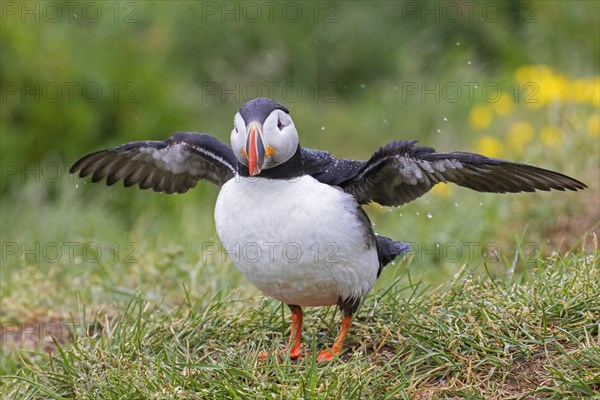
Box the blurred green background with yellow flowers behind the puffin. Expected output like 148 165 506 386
0 1 600 318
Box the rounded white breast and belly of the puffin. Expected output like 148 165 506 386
215 176 379 306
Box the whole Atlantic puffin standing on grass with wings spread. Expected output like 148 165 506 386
70 98 587 361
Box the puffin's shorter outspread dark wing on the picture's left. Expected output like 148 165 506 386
70 132 237 194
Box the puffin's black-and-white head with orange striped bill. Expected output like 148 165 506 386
231 97 298 176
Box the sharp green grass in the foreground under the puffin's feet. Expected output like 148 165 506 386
2 237 600 399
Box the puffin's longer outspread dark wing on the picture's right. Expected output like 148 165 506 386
340 140 587 206
